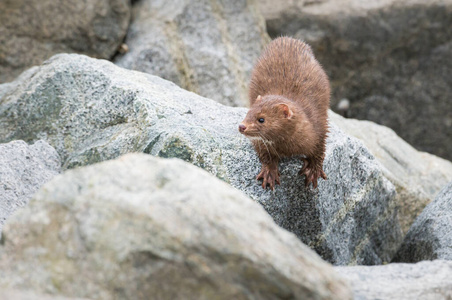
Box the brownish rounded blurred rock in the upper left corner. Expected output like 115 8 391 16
0 0 131 83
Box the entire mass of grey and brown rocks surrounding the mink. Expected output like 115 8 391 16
0 0 452 299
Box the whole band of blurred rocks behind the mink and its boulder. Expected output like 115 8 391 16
0 0 452 160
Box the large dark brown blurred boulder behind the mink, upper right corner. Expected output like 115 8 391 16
259 0 452 160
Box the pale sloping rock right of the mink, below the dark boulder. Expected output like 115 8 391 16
329 111 452 233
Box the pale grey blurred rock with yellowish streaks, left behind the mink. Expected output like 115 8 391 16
116 0 269 106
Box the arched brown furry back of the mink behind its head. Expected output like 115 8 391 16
249 37 330 115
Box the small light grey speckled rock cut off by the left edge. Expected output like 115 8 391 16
0 141 61 236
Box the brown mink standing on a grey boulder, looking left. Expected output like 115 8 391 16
239 37 330 190
